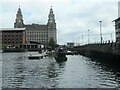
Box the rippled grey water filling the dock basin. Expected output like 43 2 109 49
0 52 120 88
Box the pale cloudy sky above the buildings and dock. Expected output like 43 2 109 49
0 0 119 45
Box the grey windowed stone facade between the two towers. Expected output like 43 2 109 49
26 24 47 44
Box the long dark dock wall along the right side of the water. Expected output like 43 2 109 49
74 43 120 65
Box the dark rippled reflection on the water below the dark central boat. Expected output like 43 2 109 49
47 61 65 88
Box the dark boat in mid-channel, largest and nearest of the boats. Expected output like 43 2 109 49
55 48 67 62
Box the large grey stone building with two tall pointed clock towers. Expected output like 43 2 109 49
14 7 57 45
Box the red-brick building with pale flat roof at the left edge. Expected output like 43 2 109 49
0 28 26 49
